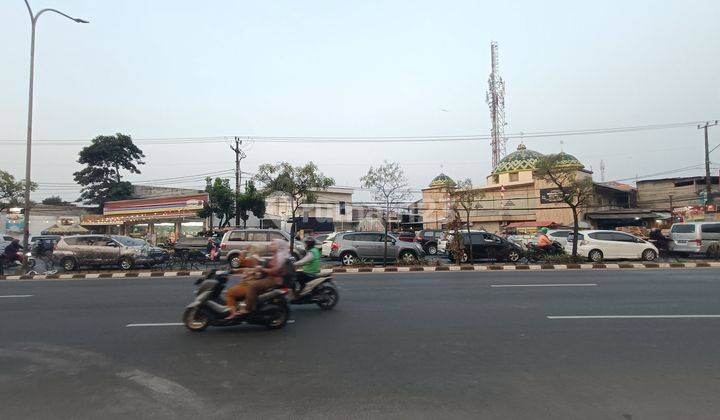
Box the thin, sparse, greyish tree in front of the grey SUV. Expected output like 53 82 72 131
360 161 412 265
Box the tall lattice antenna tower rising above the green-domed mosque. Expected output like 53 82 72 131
485 42 507 169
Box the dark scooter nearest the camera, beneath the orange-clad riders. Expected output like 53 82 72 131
182 270 290 332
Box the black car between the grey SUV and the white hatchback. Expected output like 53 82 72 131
447 232 523 263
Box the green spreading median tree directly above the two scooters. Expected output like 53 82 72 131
255 162 335 250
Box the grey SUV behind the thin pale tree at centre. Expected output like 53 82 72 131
330 232 425 265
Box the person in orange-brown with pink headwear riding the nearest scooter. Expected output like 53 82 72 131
225 239 290 319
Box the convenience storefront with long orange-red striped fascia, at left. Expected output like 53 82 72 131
81 194 208 243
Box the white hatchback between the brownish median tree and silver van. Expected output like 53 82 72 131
565 230 659 263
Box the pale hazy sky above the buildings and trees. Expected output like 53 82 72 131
0 0 720 200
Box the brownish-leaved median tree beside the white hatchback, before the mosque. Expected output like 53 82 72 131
535 153 593 258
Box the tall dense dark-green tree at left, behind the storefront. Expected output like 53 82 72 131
73 133 145 207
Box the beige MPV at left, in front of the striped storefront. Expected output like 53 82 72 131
53 235 163 271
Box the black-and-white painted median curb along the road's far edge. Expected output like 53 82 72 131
0 262 720 280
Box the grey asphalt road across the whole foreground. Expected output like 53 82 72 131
0 269 720 420
